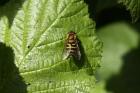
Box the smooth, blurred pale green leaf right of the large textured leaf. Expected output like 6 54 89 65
94 22 139 93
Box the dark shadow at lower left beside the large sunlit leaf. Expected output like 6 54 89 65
0 43 27 93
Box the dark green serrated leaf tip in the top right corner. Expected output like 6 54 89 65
118 0 140 22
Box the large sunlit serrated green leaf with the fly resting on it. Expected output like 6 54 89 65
0 0 102 93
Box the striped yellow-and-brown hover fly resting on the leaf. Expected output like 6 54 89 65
63 31 81 60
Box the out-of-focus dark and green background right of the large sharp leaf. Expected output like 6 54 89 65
85 0 140 93
